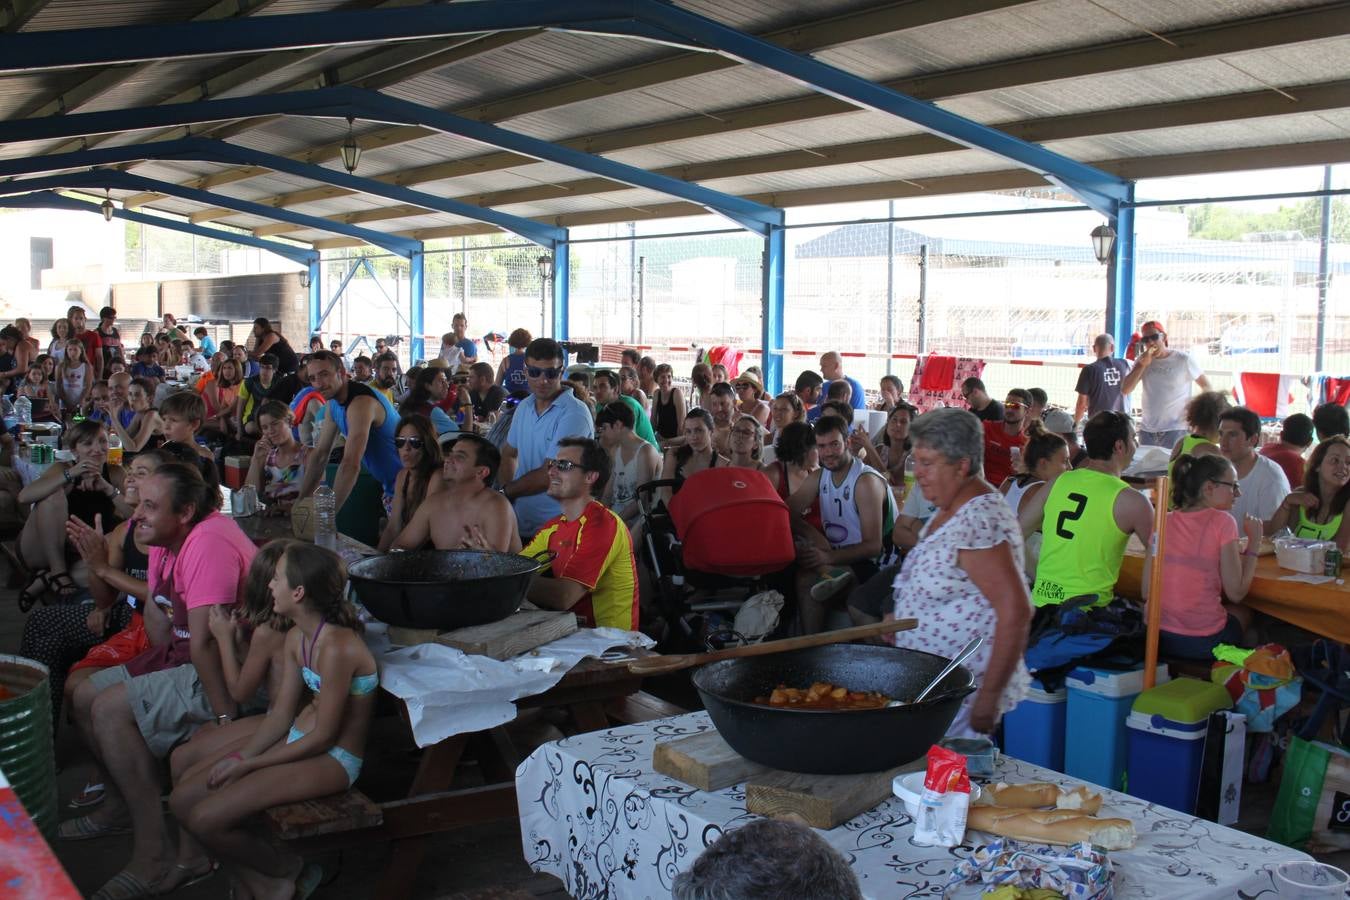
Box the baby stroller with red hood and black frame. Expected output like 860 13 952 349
637 467 795 652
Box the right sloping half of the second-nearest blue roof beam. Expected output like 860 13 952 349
332 88 783 235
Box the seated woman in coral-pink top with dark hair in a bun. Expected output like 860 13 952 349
1143 453 1261 660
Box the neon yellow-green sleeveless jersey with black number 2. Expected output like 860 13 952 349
1031 468 1130 606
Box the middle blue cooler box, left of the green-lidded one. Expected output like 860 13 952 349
1064 665 1168 791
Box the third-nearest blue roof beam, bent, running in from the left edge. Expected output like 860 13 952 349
0 138 567 250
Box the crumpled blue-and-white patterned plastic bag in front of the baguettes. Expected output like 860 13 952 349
944 838 1112 900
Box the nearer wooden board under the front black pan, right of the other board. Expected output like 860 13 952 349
745 757 927 828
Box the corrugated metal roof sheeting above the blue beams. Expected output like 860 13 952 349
0 0 1350 249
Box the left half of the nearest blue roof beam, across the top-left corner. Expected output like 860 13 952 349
0 0 626 73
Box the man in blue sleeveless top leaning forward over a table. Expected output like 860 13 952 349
300 349 402 510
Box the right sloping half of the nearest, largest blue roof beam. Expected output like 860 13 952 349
613 0 1129 217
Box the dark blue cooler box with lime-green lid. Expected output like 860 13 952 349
1126 679 1233 815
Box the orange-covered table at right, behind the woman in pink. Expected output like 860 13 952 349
1115 546 1350 644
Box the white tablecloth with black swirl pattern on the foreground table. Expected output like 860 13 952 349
516 712 1307 900
